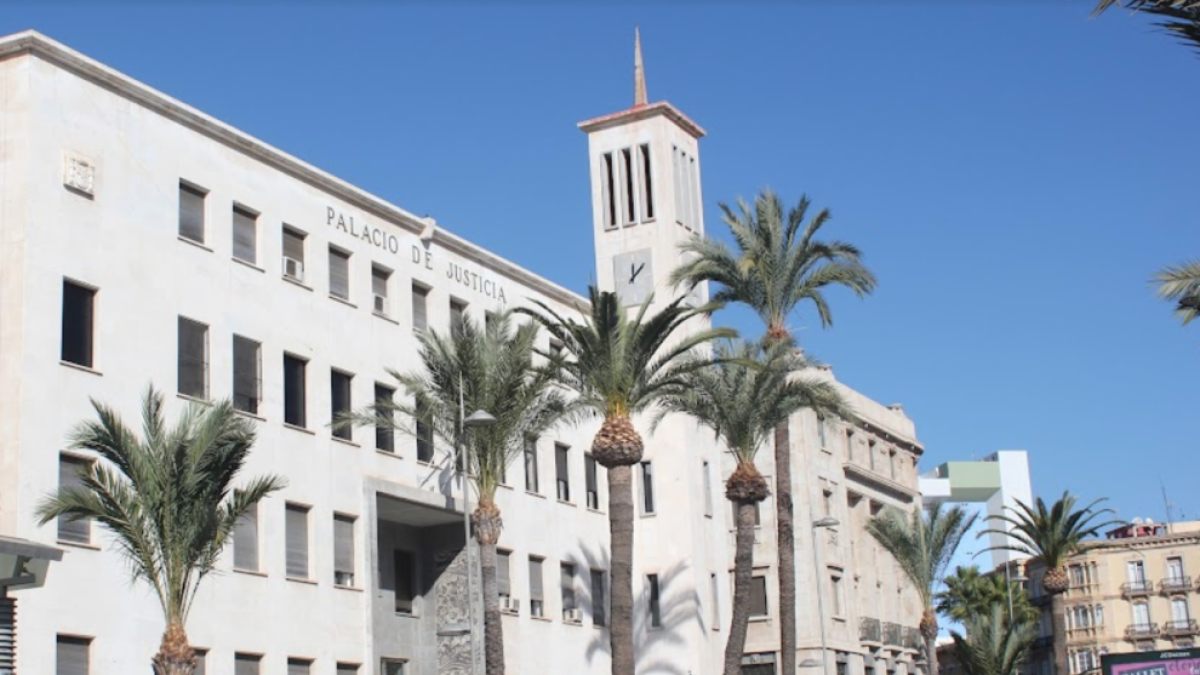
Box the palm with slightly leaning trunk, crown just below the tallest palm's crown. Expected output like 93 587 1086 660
656 342 851 675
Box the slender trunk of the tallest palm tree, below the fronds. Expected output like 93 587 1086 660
775 419 796 675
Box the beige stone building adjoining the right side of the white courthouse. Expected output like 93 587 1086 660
739 368 924 675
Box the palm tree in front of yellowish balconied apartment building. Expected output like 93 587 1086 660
983 492 1117 673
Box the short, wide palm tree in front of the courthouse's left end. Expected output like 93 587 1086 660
37 387 284 675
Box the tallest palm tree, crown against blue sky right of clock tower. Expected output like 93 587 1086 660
671 189 875 673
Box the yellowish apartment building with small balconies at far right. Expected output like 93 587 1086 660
1027 519 1200 675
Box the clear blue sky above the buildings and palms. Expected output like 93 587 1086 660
0 0 1200 519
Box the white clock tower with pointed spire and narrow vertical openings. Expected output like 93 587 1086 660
580 31 708 307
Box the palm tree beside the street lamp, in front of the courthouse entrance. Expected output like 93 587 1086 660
335 311 570 675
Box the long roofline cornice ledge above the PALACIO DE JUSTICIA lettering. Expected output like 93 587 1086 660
0 30 587 307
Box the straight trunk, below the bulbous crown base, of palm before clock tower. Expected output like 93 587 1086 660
607 464 634 675
